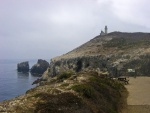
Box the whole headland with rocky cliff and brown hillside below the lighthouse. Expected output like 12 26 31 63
43 32 150 76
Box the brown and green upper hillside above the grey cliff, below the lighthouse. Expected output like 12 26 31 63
54 32 150 60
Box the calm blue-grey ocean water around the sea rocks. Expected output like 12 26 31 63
0 60 47 102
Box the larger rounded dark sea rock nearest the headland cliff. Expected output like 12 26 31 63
31 59 49 74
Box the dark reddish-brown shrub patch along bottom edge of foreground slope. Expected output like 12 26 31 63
34 93 85 113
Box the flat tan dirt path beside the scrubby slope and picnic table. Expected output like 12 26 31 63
123 77 150 113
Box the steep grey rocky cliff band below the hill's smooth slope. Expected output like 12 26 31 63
48 56 112 76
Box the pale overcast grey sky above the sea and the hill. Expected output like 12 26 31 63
0 0 150 59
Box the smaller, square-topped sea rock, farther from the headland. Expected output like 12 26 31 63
17 61 29 72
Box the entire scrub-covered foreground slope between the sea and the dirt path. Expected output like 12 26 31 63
0 71 127 113
